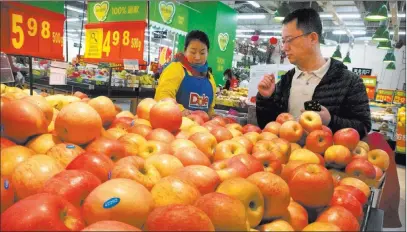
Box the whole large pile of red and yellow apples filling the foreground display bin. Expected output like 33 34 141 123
1 96 389 231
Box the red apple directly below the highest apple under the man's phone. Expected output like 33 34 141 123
305 130 333 154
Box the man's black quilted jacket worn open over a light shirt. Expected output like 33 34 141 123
256 59 372 139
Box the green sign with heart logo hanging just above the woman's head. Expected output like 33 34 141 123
150 0 189 32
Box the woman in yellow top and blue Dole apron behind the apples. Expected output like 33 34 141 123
155 31 216 115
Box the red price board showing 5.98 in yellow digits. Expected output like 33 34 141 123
1 1 65 60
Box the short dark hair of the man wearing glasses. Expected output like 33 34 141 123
282 8 322 40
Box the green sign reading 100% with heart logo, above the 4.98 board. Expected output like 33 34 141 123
88 1 147 23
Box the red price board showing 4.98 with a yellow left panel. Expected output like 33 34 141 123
85 21 146 63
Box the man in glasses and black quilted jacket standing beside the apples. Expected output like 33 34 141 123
256 9 372 138
